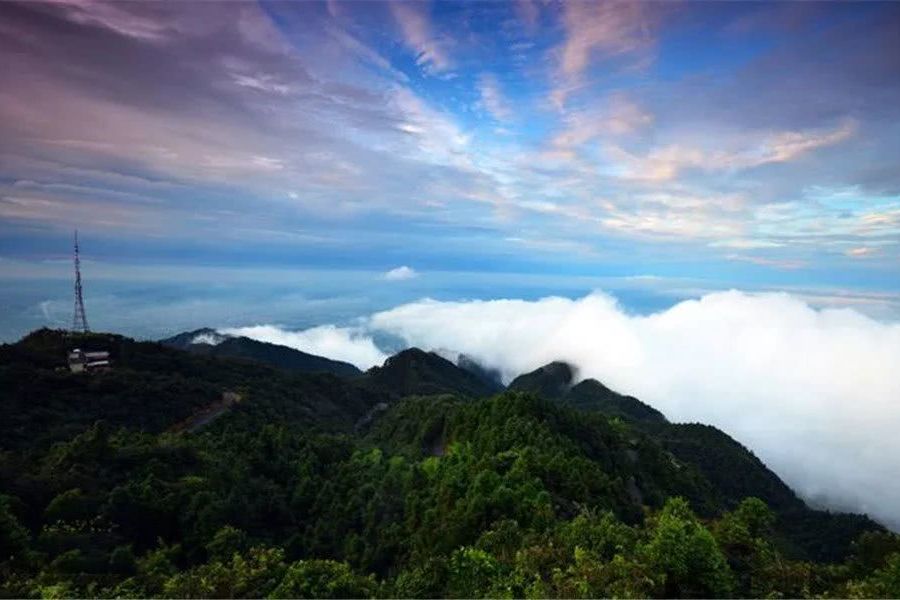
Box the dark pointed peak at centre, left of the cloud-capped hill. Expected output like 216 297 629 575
365 348 502 398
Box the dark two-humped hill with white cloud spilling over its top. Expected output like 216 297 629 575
509 362 666 423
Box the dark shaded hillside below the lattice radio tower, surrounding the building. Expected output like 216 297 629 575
0 329 387 449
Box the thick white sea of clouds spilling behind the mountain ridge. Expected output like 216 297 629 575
228 291 900 530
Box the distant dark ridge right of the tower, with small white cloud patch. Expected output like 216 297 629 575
160 328 362 377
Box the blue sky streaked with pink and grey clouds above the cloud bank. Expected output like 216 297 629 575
0 0 900 339
